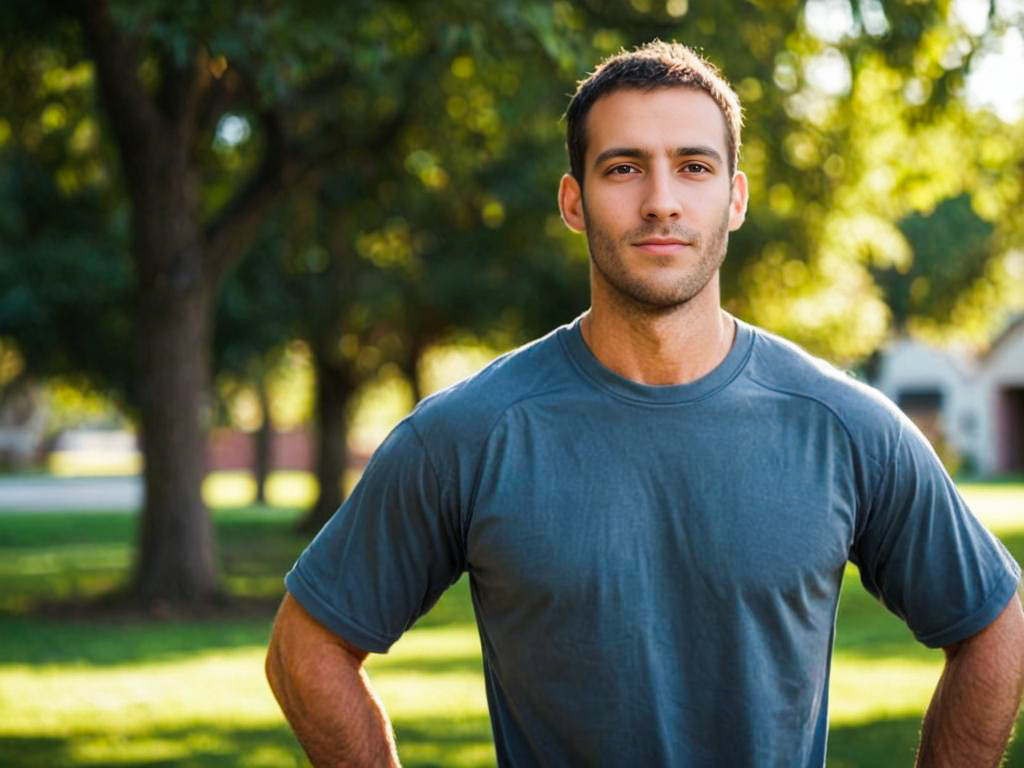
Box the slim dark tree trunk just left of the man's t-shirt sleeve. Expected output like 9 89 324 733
299 345 358 532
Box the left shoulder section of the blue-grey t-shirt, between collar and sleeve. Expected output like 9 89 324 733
409 326 579 450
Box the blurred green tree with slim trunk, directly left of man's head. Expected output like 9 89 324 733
202 3 586 527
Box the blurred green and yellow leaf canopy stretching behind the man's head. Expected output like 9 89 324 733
0 0 1022 403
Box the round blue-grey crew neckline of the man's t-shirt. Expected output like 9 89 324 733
558 315 754 404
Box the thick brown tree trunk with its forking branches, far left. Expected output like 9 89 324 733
72 0 288 606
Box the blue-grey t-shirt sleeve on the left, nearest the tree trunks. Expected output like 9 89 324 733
285 420 465 652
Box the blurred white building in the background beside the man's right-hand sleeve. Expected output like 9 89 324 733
873 315 1024 475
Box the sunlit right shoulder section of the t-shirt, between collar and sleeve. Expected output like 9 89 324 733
748 329 904 444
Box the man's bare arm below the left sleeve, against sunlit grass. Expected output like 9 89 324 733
266 594 398 768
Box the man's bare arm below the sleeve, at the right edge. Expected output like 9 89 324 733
918 594 1024 768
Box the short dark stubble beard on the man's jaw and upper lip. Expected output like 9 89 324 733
584 202 729 314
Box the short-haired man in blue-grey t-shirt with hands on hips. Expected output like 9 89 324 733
267 43 1024 767
